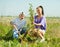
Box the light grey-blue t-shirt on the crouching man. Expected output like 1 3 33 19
11 18 26 31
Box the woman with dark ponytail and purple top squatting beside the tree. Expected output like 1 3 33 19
33 6 46 42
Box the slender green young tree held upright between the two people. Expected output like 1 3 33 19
24 3 34 37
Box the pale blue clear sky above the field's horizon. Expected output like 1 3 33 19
0 0 60 17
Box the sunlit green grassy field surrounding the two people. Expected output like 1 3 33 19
0 17 60 47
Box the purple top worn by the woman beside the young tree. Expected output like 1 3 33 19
34 16 46 30
